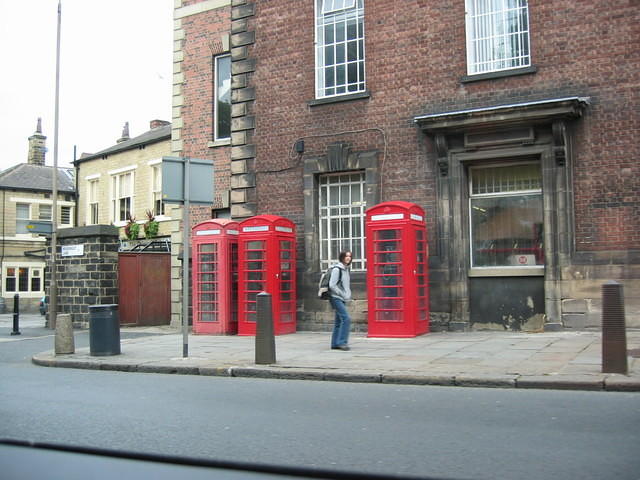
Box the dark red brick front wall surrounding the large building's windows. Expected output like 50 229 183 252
251 0 640 250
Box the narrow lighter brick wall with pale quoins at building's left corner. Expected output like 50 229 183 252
171 0 231 326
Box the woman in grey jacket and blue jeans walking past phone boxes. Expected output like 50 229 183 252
329 251 351 350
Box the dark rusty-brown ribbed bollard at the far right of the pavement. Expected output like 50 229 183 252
602 281 628 375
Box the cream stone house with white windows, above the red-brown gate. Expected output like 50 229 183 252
74 120 172 247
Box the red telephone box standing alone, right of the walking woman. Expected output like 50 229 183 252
366 202 429 337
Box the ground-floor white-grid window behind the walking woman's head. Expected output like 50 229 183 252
319 172 366 270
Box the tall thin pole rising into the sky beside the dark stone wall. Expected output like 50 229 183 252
49 0 62 328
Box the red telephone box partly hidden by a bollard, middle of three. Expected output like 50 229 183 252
238 215 296 335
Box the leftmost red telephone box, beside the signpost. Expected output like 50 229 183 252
191 219 240 334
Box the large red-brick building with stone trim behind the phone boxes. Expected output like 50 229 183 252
173 0 640 330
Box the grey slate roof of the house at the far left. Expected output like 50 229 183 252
0 163 76 193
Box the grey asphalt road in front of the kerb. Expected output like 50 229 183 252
0 316 640 480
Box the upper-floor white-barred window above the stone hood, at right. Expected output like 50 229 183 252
466 0 531 75
